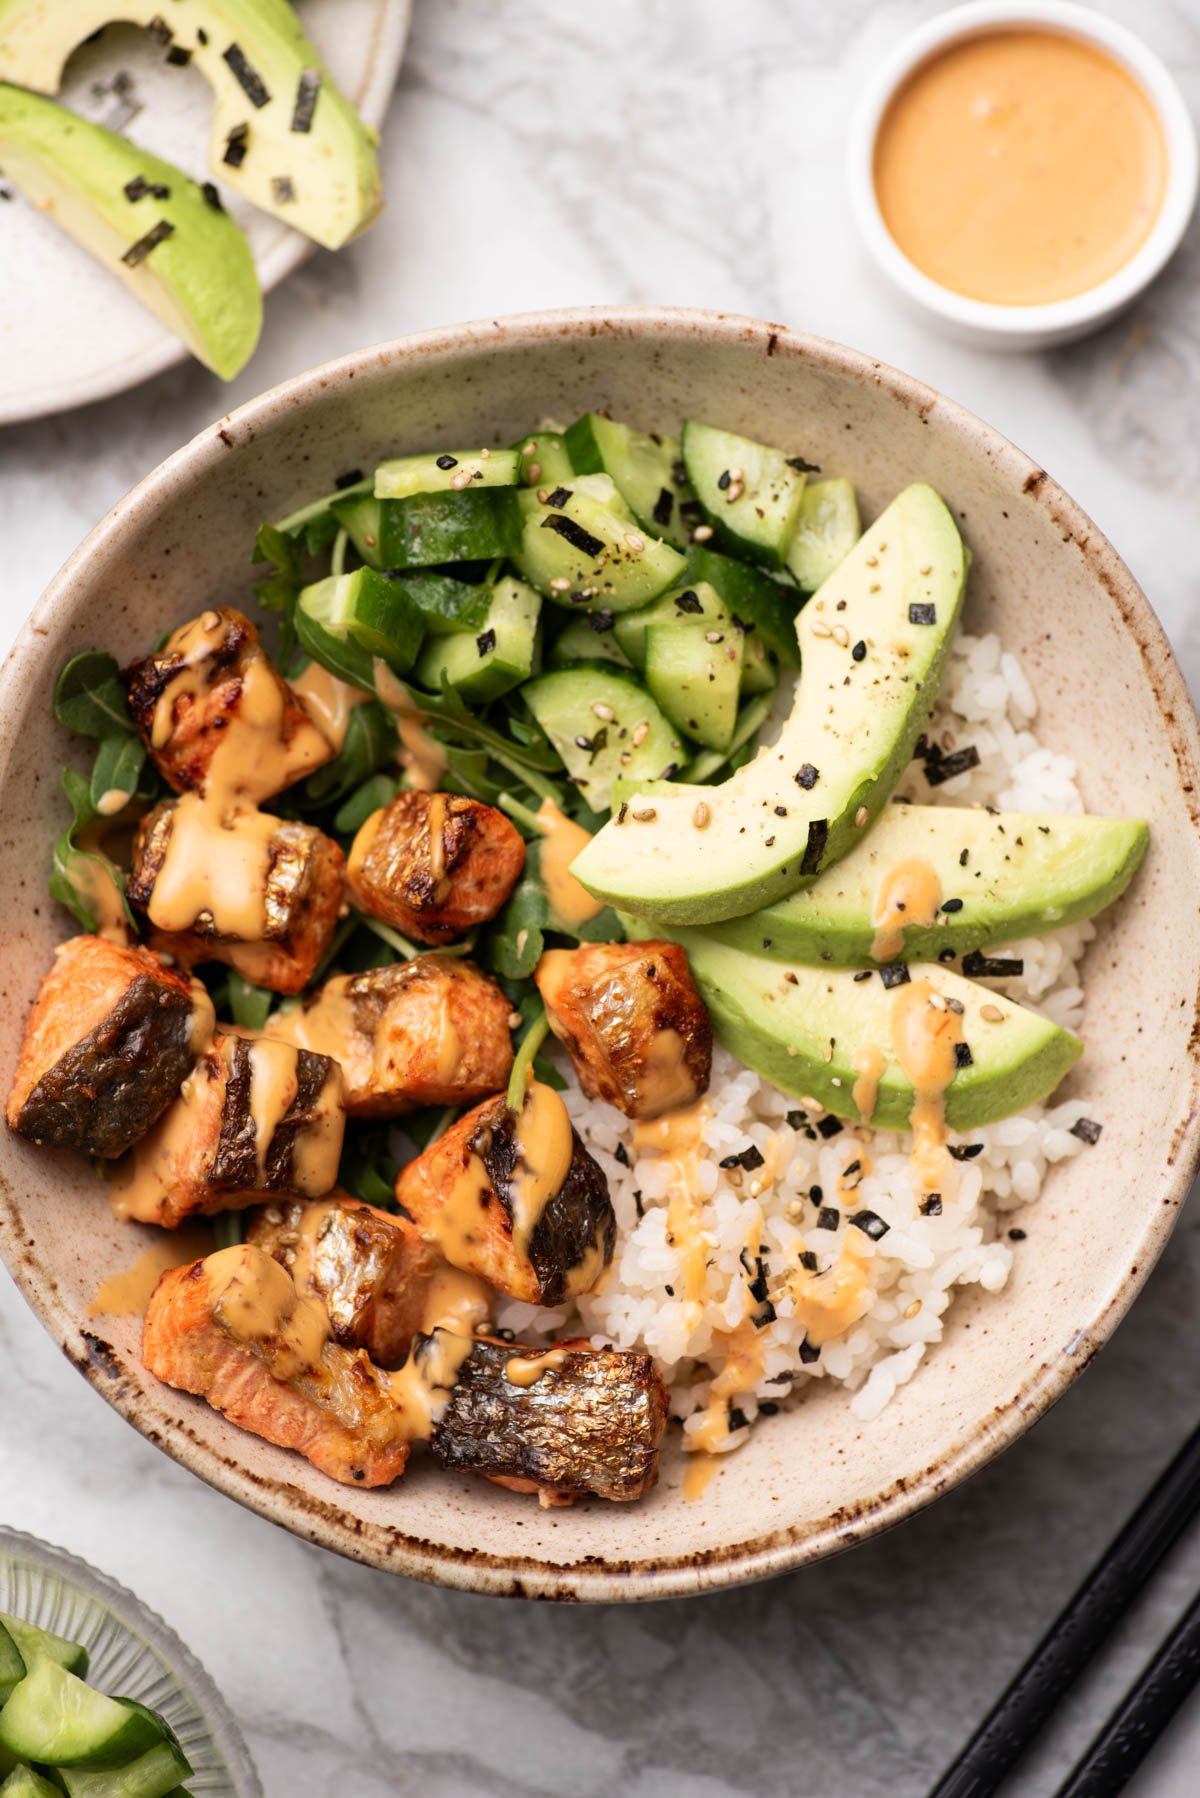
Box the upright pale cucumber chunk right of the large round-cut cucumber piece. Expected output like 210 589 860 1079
646 583 745 750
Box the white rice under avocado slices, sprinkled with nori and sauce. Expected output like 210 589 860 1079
498 636 1094 1449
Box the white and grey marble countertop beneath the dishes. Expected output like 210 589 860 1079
0 0 1200 1798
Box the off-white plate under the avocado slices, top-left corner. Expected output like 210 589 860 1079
0 0 412 424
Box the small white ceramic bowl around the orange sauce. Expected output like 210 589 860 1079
847 0 1200 349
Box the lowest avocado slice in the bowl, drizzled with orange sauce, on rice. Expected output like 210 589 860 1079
622 919 1083 1131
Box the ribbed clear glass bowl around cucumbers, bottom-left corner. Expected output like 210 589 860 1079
0 1530 263 1798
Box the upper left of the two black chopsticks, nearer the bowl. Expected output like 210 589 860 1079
930 1426 1200 1798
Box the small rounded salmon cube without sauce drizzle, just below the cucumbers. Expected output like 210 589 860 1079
345 791 525 942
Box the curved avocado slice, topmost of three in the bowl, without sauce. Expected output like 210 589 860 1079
572 485 968 924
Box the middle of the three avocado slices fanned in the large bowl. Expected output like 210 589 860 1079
711 806 1150 967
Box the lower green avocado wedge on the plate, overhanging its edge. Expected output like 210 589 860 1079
0 83 263 381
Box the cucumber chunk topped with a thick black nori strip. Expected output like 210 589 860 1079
513 475 684 611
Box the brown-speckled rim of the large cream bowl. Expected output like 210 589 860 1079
0 306 1200 1602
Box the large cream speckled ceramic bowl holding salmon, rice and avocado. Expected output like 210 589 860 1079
0 309 1200 1600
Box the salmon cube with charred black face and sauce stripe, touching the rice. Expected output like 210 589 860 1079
396 1082 617 1305
